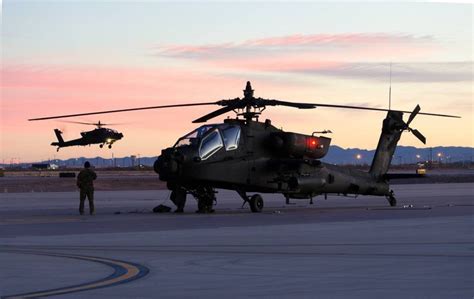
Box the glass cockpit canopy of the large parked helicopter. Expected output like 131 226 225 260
174 124 240 160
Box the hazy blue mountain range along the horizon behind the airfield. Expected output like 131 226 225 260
0 145 474 167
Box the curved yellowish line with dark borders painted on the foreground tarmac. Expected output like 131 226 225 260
2 250 150 299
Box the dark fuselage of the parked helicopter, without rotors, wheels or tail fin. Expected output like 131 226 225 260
155 119 389 209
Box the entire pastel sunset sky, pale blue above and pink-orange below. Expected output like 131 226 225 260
0 1 473 163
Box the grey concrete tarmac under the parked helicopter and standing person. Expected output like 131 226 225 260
0 183 474 298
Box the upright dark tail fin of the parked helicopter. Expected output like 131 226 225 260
369 111 406 177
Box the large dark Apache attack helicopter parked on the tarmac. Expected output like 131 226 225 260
30 82 459 213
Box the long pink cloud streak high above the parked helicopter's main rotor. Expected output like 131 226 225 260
154 33 438 75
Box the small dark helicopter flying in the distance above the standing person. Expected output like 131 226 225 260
51 121 123 152
